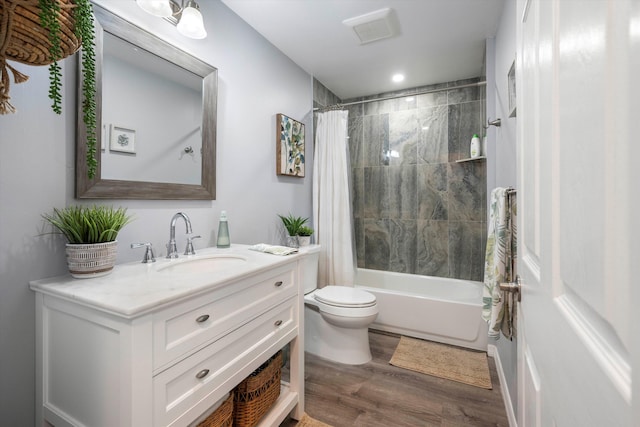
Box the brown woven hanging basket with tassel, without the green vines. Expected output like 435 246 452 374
0 0 81 114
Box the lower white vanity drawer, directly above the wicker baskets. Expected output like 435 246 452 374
153 297 298 426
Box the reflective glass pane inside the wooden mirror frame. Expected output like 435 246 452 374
101 33 202 184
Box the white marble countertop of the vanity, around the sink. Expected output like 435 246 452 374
29 244 305 318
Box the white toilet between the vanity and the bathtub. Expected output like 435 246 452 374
300 245 378 365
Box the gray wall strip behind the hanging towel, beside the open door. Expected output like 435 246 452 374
487 1 518 418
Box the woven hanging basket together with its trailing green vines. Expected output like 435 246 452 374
0 0 98 178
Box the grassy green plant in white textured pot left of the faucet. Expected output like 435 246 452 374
42 205 132 279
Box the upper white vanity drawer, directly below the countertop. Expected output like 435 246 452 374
153 264 297 372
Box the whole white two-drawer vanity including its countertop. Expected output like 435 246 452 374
31 247 304 427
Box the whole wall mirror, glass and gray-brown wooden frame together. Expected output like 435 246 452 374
76 5 217 200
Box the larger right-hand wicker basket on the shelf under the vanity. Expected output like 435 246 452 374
233 351 282 427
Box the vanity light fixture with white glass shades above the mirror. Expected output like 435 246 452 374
136 0 207 39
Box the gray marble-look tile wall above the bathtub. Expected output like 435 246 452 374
344 79 486 281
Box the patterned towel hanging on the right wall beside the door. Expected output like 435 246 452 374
482 188 517 339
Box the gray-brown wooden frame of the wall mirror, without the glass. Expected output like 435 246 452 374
76 5 218 200
